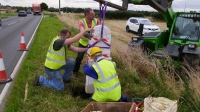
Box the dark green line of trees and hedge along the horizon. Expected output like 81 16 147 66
7 2 164 21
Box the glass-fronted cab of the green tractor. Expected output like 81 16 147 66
171 14 200 42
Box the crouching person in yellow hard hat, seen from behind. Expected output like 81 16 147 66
83 47 126 102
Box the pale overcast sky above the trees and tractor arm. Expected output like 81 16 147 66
0 0 200 12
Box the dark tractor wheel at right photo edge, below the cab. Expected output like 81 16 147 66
183 54 200 70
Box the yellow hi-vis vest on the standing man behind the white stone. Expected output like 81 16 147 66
79 18 97 47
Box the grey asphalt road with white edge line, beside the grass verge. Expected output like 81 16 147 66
0 14 43 107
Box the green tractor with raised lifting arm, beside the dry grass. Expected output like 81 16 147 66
95 0 200 69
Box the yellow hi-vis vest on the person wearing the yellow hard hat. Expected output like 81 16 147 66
92 59 121 102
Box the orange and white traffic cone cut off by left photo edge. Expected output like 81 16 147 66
0 51 12 84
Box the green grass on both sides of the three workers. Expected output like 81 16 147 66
4 17 200 112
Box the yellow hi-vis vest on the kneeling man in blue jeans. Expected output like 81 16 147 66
45 36 67 70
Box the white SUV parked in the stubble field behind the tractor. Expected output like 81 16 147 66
126 17 160 34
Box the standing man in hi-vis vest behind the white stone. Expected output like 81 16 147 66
73 8 100 75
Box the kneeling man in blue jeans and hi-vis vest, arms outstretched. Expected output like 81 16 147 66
34 28 93 90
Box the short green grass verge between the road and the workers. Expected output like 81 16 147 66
4 17 89 112
